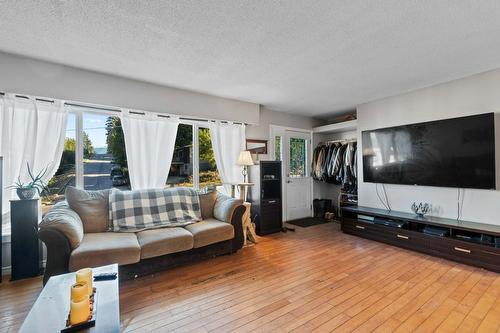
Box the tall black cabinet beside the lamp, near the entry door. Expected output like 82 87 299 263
248 161 283 235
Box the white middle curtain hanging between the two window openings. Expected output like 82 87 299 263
122 111 179 190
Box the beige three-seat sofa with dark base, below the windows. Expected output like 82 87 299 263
39 188 245 283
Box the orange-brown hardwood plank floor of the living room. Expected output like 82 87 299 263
0 220 500 332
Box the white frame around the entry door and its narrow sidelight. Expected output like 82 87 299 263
268 124 314 223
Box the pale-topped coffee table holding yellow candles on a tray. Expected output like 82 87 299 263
19 264 120 333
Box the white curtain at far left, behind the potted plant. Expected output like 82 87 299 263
0 94 67 214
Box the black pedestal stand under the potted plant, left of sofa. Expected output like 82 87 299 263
10 199 41 280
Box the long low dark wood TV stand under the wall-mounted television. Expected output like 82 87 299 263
341 207 500 272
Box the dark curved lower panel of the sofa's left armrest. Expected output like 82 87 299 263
38 228 72 285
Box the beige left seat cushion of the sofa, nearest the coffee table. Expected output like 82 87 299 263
69 232 141 271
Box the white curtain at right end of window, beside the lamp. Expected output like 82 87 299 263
209 122 245 194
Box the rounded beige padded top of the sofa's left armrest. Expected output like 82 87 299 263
39 201 83 249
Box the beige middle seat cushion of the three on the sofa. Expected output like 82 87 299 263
137 227 193 259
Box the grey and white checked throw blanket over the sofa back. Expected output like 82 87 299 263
109 187 201 232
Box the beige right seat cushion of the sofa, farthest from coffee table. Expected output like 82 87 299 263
185 219 234 248
